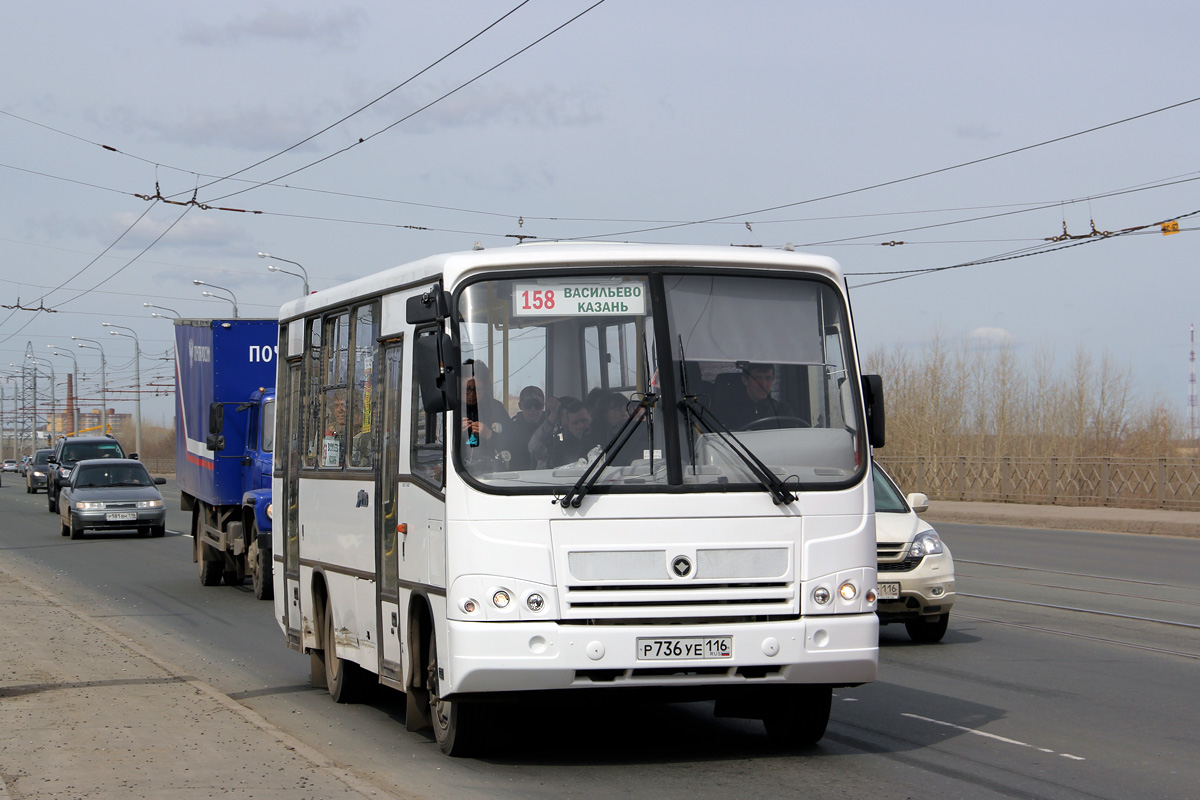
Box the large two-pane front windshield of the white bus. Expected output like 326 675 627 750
455 267 865 492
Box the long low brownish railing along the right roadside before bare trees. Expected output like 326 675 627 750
876 455 1200 511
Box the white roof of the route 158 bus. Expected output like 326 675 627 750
280 242 842 320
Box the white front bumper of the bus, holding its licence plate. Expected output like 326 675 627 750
443 613 878 696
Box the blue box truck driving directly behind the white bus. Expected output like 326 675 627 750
175 319 278 600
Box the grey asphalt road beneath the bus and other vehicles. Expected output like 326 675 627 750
0 481 1200 800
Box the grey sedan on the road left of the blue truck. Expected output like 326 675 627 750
59 458 167 539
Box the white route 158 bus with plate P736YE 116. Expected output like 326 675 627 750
272 243 883 756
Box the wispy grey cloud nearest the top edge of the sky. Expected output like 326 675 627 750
180 6 367 48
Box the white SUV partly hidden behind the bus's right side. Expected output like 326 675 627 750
874 464 954 643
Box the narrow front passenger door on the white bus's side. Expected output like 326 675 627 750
374 341 407 688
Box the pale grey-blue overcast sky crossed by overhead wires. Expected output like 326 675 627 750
0 0 1200 422
